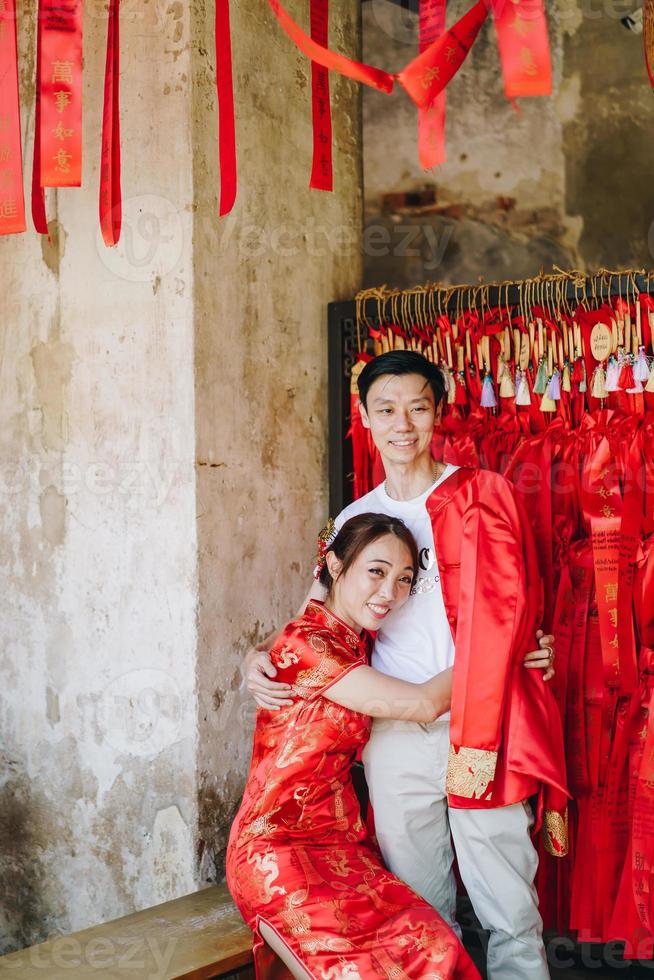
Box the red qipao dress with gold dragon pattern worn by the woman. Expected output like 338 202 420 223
227 602 479 980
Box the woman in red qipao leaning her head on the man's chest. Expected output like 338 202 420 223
227 514 479 980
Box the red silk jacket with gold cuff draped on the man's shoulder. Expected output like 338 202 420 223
427 467 568 855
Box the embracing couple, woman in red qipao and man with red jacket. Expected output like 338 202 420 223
228 351 566 980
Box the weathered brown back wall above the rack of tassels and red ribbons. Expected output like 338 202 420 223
363 0 654 286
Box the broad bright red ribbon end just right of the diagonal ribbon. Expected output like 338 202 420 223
492 0 552 99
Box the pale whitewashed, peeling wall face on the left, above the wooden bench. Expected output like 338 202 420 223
0 3 197 952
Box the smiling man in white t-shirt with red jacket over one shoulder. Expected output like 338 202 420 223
248 351 564 980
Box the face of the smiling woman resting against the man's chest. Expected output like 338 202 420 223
327 534 413 631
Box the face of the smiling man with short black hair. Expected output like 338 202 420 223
361 374 436 463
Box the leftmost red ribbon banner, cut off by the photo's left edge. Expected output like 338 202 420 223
0 0 26 235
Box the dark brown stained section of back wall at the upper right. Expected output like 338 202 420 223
559 0 654 269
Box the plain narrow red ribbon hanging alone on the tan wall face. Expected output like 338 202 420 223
216 0 236 216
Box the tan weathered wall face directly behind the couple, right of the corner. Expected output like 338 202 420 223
194 0 361 875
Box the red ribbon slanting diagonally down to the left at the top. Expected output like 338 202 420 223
397 0 488 108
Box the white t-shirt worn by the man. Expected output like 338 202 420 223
335 465 458 696
